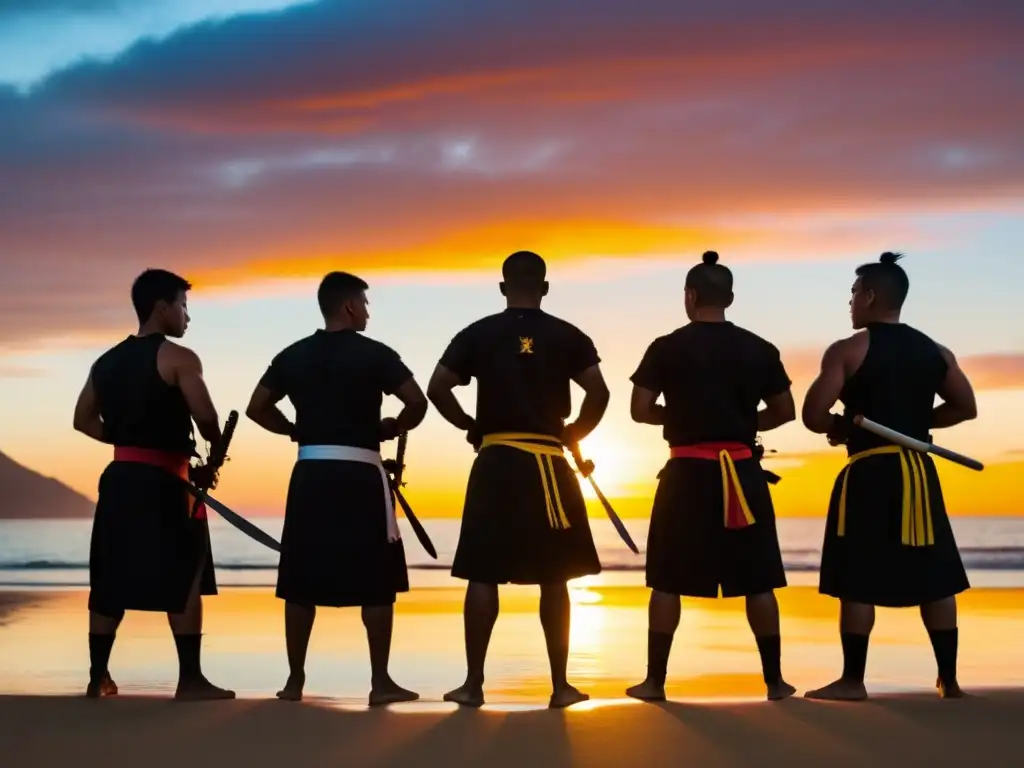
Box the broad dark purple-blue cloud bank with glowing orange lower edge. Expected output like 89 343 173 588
0 0 1024 345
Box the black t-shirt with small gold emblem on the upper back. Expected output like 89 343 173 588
440 308 601 435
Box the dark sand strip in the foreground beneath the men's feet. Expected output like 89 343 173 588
0 691 1024 768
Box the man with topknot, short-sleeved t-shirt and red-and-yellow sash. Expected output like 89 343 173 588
627 251 796 700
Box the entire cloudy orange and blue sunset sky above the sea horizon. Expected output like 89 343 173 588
0 0 1024 515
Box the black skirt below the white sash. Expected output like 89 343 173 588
276 460 409 607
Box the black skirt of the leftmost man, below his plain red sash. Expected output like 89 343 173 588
89 462 217 615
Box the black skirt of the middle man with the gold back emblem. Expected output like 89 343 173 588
452 445 601 584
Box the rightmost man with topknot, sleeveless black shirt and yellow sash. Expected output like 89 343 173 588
803 253 977 700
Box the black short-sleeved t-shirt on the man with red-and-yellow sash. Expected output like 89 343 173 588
630 323 791 445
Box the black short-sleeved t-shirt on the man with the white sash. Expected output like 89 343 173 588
260 330 413 451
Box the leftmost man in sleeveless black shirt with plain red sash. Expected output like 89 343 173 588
74 269 234 700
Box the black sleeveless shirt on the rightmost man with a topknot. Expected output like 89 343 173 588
840 323 948 456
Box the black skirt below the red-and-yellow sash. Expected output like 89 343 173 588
647 459 786 597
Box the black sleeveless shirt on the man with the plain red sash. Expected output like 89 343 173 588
92 334 196 456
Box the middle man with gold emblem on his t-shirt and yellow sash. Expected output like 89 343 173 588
427 251 608 708
